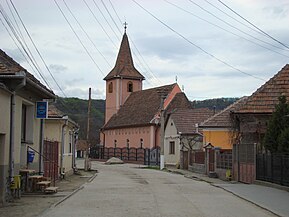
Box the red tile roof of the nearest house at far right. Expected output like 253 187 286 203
236 64 289 113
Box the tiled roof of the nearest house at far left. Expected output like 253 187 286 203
0 49 54 95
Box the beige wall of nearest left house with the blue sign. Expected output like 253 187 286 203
0 90 40 203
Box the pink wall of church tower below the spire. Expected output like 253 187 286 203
105 78 142 123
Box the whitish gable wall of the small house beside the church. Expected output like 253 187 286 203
164 118 180 166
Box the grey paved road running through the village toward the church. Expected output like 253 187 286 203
43 162 274 217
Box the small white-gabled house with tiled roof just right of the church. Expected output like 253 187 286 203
164 108 214 169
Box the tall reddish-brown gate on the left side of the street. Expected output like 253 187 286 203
43 140 58 181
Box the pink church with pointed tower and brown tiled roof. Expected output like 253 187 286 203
100 31 191 149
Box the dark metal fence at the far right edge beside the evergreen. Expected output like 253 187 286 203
256 153 289 186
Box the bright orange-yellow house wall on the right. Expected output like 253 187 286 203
203 129 233 149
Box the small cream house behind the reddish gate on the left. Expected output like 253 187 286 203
44 105 79 177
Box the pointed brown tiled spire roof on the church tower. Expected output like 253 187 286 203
104 33 145 80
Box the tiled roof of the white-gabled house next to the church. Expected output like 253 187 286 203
171 108 214 134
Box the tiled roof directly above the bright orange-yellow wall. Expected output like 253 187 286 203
200 97 247 128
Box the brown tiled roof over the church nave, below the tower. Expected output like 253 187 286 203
103 84 190 129
